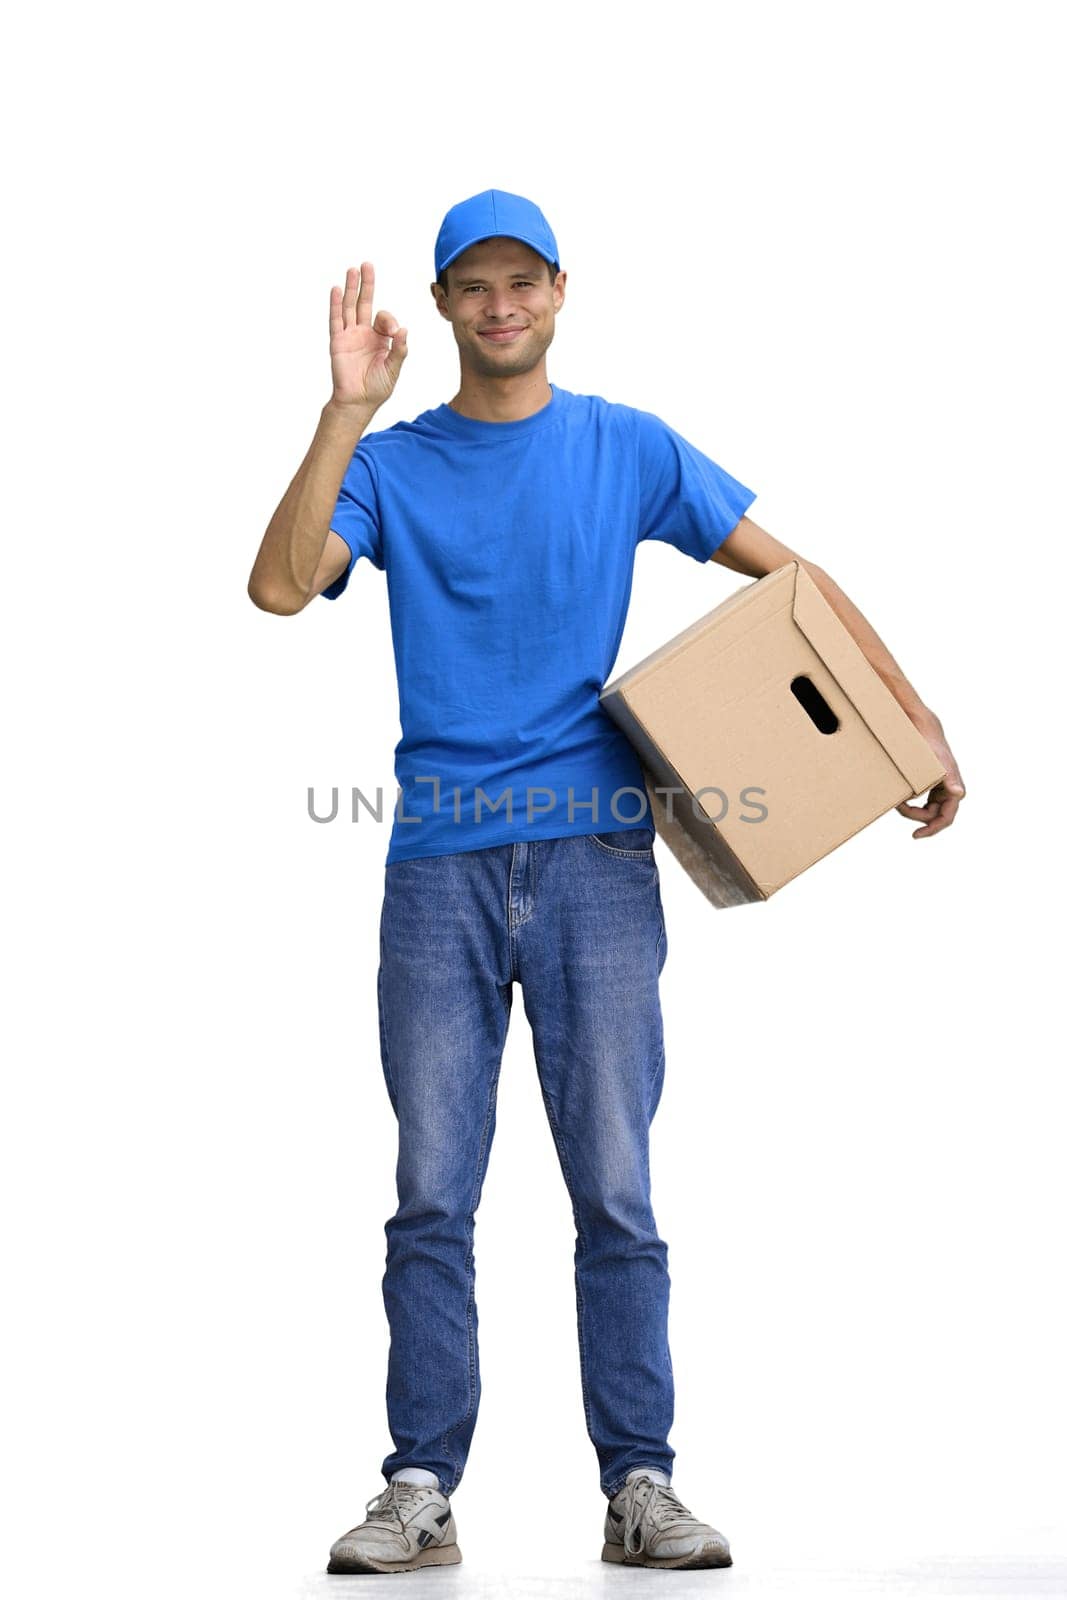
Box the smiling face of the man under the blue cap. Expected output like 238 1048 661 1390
432 238 566 378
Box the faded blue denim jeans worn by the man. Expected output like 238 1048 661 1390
378 827 675 1494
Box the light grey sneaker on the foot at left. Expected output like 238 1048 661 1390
326 1478 462 1573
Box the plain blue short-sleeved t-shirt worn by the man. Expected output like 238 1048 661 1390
323 384 755 866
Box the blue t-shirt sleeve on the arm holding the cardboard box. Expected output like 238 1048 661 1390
633 410 755 562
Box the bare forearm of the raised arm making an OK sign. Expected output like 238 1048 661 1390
248 400 374 613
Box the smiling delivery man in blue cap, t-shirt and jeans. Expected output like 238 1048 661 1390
248 189 965 1571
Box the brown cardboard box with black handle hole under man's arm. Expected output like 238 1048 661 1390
600 562 945 907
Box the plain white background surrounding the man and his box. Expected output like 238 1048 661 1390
2 0 1067 1595
